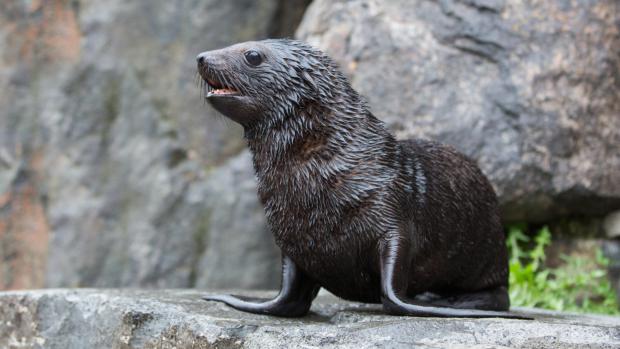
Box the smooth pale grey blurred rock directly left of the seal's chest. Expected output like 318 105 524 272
195 151 281 289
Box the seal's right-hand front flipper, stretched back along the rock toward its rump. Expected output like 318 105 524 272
380 236 531 319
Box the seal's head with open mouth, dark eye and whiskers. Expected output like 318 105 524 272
197 39 363 128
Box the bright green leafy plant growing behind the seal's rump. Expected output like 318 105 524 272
507 226 620 314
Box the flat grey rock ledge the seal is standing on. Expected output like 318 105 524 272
0 289 620 349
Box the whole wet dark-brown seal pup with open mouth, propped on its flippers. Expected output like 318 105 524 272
197 39 520 318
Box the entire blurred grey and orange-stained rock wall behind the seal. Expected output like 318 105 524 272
0 0 620 298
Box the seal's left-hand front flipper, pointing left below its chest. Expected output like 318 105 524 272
203 256 319 317
